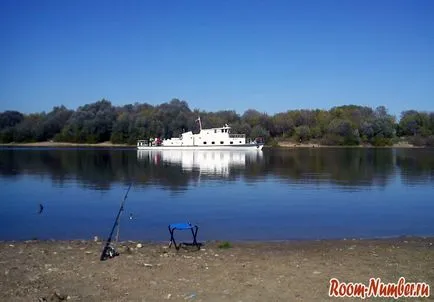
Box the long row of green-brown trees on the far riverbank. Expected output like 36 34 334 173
0 99 434 146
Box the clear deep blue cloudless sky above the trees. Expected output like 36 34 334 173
0 0 434 115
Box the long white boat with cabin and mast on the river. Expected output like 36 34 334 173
137 117 264 150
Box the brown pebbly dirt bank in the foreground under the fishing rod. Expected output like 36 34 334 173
0 238 434 301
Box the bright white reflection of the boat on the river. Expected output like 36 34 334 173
137 150 263 176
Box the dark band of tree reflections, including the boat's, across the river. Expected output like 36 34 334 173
0 148 434 191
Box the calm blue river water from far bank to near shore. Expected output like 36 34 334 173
0 148 434 241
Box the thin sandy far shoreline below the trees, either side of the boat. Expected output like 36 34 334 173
0 142 428 149
